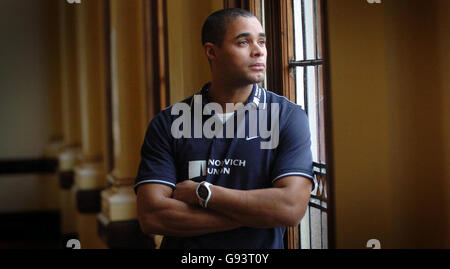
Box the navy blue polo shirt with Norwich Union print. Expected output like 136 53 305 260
135 83 314 249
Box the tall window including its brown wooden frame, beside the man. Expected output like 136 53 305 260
249 0 333 249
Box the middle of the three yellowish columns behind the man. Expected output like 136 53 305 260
75 0 107 249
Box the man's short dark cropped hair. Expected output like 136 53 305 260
202 8 256 47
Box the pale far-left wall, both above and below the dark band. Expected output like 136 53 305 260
0 0 57 214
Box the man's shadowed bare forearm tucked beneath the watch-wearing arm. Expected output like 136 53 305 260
141 195 240 237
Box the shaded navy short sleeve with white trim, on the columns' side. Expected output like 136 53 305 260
134 114 176 193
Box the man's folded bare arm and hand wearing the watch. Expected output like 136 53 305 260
174 176 312 228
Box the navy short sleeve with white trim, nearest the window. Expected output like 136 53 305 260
271 106 315 191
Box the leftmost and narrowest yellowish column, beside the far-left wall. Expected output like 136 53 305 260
58 1 81 240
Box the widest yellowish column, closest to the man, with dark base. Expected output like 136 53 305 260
98 0 154 248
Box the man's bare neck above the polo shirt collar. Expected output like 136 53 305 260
208 81 253 113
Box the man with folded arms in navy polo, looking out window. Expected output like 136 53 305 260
135 9 313 249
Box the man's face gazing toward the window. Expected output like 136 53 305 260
215 17 267 85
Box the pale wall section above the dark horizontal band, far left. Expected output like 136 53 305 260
0 0 50 159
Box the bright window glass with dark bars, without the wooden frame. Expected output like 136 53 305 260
289 0 328 249
